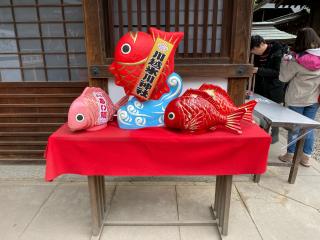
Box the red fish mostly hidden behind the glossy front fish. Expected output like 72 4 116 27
199 84 257 122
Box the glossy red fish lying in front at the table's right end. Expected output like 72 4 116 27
164 89 244 134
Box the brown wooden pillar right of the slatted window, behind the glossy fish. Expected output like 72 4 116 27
228 0 253 105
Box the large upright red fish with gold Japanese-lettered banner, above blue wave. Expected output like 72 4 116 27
109 28 183 101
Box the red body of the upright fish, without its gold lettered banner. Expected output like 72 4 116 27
109 28 183 101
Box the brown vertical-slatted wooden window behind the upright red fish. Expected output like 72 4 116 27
103 0 222 58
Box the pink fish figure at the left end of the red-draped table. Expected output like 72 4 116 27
68 87 129 131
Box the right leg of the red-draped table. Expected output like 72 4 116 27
213 175 232 236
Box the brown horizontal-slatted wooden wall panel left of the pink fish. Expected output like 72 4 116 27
0 82 87 164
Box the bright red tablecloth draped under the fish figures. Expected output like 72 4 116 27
45 122 271 181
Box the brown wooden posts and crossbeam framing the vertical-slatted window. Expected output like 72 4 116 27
83 0 253 105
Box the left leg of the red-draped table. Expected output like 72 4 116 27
88 176 106 240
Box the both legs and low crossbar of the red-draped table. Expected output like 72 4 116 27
88 175 232 240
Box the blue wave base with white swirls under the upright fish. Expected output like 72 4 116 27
117 73 182 129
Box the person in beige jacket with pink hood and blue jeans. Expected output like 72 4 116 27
279 28 320 167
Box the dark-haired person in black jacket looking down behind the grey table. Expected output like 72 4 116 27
250 35 285 143
